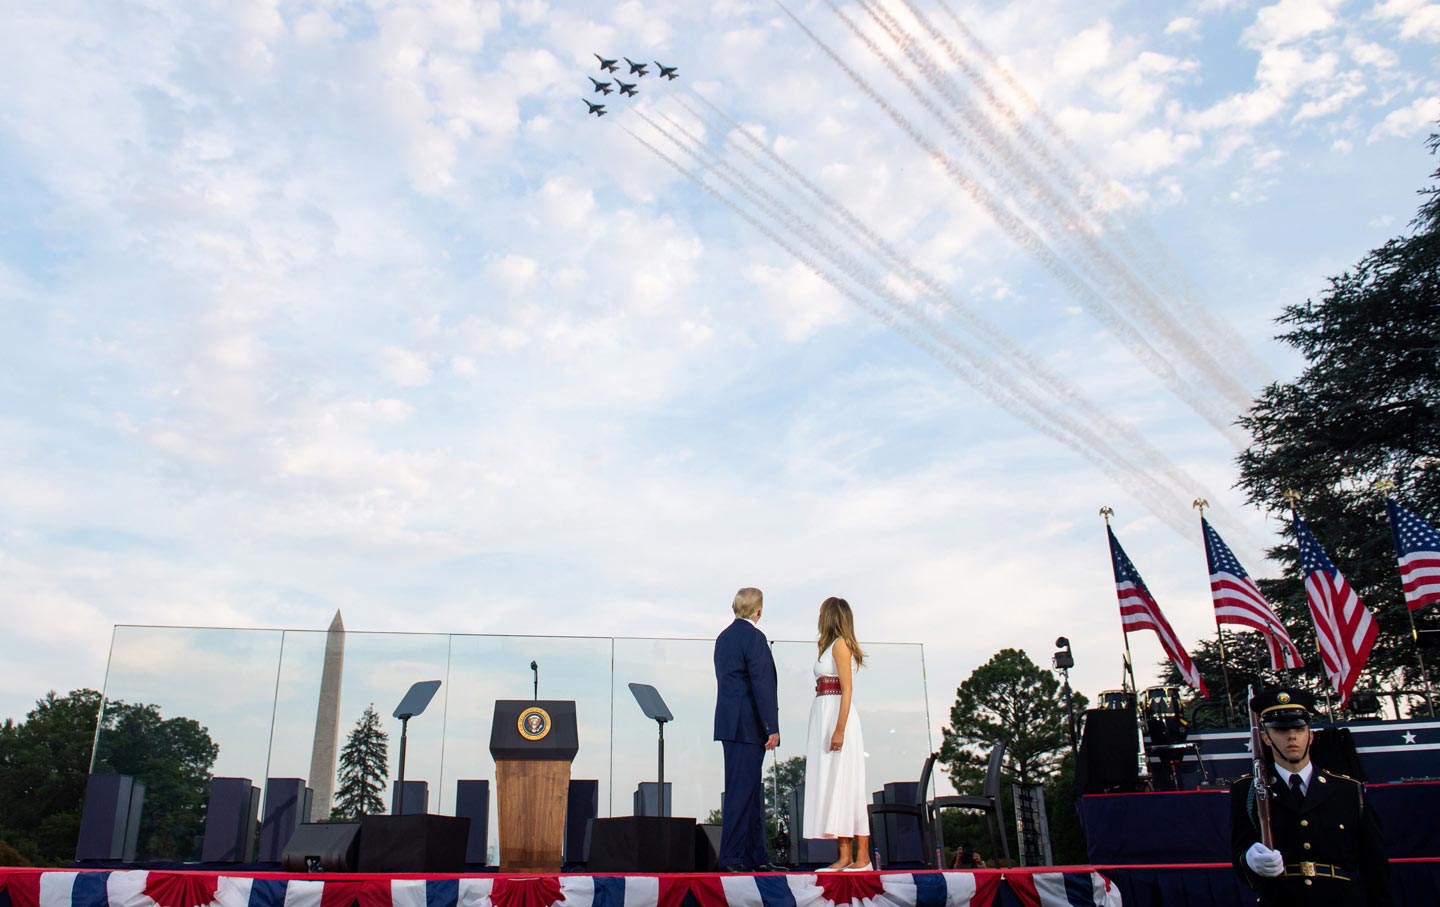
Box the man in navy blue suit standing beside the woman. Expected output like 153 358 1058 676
716 587 783 872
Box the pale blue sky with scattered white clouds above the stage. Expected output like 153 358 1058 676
0 0 1440 748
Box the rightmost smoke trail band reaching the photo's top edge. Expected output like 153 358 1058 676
921 0 1270 388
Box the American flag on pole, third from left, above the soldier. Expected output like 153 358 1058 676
1295 515 1378 707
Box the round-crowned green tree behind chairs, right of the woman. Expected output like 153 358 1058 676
940 649 1086 865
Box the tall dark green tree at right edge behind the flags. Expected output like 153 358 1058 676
1207 125 1440 711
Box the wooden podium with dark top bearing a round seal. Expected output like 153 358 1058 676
490 700 580 872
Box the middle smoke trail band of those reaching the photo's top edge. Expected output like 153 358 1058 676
858 0 1250 420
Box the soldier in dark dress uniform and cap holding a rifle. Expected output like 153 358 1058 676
1230 688 1391 907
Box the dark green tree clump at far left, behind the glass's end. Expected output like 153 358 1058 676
0 690 219 865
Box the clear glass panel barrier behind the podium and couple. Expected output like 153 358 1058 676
92 626 933 861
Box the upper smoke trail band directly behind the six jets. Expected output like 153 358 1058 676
665 94 1259 547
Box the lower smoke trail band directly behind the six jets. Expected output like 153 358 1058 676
631 111 1249 544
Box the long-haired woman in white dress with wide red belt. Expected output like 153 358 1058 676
805 597 870 872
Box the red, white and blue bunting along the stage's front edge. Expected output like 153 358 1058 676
0 867 1120 907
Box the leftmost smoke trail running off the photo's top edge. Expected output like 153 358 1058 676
776 0 1236 449
